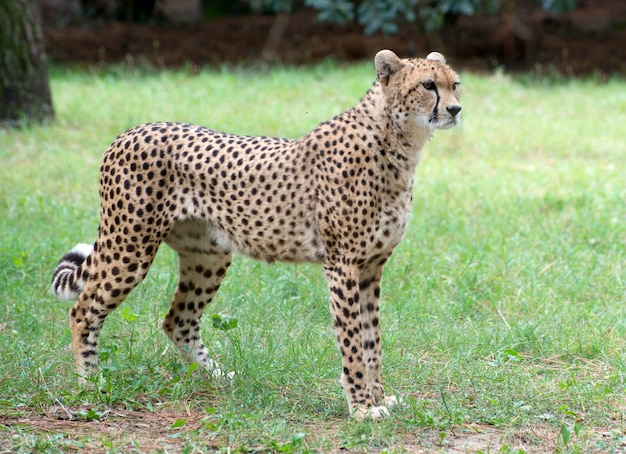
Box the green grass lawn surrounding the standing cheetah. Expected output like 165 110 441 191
0 64 626 452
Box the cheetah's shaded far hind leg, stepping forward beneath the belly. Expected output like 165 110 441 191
163 248 234 379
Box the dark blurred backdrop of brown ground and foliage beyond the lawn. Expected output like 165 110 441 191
41 0 626 75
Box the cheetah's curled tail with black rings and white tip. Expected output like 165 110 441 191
52 243 93 300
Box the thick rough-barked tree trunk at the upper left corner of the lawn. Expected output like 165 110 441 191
0 0 54 124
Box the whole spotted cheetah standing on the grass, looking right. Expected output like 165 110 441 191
52 50 461 419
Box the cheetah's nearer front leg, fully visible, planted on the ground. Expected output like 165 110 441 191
324 260 388 419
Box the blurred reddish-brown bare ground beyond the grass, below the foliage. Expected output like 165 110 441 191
45 0 626 75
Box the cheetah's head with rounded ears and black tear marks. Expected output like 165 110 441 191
374 50 461 135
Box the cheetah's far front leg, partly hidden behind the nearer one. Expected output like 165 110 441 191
359 258 398 407
